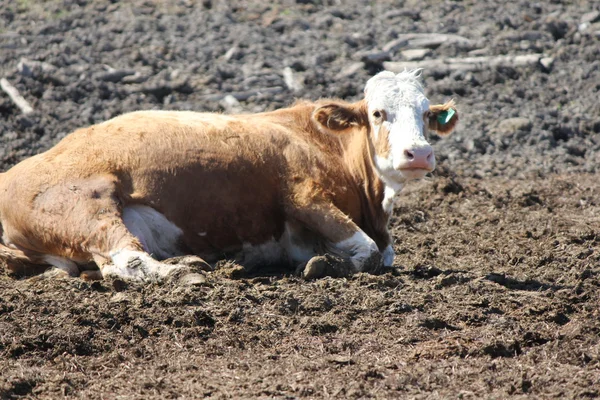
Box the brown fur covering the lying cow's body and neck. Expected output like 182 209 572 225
0 100 390 271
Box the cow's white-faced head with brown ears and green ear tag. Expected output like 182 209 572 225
314 70 458 187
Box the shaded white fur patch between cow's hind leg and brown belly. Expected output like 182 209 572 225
123 205 184 259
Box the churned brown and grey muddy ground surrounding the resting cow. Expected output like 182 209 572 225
0 0 600 399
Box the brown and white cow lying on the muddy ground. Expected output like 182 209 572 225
0 71 458 280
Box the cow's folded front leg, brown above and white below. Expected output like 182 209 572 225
290 202 382 278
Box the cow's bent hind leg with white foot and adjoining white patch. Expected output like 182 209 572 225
25 175 209 281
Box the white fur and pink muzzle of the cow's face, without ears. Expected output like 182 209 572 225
365 70 435 186
